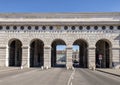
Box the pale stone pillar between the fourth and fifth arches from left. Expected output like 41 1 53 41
88 47 96 69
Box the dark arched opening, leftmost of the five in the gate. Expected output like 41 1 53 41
9 39 22 67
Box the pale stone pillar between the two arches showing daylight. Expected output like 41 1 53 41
66 46 73 69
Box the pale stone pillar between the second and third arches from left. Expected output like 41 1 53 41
44 45 51 68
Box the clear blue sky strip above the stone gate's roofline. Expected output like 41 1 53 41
0 0 120 12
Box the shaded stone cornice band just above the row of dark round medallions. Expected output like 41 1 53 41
0 21 120 26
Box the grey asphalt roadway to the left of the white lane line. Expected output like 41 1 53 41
0 68 72 85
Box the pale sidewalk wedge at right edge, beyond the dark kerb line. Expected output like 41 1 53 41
96 69 120 77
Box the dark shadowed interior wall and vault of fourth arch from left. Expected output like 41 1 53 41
72 39 88 68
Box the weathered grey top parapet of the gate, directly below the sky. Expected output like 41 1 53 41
0 12 120 18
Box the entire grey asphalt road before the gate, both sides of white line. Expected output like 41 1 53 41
0 68 120 85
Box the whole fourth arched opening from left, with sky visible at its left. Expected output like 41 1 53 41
72 39 88 68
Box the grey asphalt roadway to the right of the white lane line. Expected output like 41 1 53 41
71 68 120 85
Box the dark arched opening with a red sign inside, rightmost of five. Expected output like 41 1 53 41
96 40 111 68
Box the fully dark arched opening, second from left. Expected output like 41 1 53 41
30 39 44 67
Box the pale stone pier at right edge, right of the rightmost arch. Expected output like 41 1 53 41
110 47 120 68
